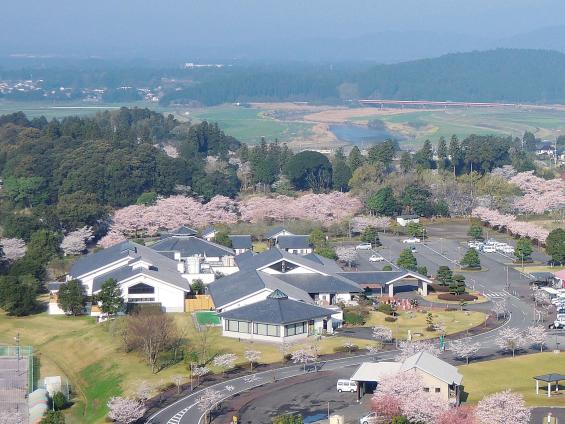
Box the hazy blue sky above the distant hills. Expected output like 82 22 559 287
0 0 565 57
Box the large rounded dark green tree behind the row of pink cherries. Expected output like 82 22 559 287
286 150 332 193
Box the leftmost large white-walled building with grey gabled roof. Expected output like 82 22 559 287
49 241 190 316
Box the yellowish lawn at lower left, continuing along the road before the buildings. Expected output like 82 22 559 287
0 312 370 424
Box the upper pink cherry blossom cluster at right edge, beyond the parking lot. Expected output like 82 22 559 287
510 171 565 214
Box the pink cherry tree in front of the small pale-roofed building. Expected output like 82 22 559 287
371 370 449 423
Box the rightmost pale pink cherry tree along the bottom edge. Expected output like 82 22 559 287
475 390 531 424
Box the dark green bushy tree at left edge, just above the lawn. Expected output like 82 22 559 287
0 275 39 316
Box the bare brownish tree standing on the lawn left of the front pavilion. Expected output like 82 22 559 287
127 310 177 373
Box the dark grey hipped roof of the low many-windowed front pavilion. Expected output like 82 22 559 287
215 298 333 324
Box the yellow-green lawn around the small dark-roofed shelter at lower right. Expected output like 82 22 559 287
459 352 565 406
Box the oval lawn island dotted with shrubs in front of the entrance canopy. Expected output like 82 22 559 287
366 310 486 340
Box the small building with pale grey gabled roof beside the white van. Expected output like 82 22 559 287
350 352 463 405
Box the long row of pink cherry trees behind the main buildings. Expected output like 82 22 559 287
99 192 363 247
